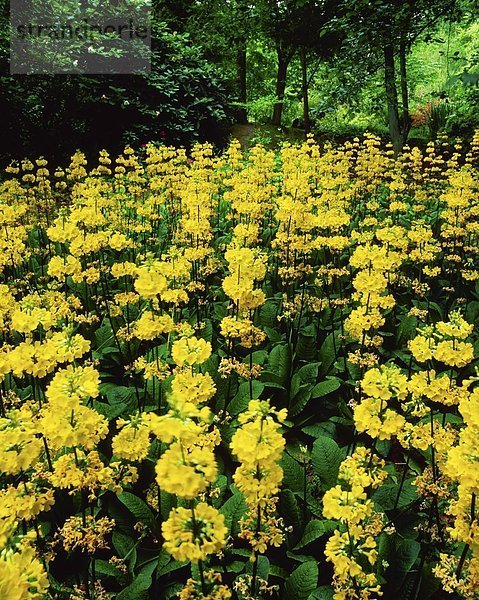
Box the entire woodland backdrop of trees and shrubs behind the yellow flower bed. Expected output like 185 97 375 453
0 0 479 164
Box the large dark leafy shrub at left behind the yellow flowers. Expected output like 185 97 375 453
0 23 231 163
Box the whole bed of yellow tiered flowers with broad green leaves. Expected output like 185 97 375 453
0 133 479 600
